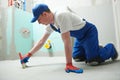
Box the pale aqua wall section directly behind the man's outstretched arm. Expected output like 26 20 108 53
33 22 64 57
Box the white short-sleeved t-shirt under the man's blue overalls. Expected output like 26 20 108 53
46 11 86 33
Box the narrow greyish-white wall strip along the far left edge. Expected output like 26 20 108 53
0 0 8 60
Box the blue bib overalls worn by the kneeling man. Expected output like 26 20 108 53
50 22 115 61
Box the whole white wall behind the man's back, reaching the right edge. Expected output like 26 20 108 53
68 0 120 53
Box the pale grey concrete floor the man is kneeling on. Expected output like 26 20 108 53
0 57 120 80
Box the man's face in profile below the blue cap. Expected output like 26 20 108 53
38 12 50 25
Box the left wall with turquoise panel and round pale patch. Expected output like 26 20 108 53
0 7 33 60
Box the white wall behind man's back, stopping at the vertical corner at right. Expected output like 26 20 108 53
68 0 116 45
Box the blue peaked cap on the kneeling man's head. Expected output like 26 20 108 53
31 4 49 23
